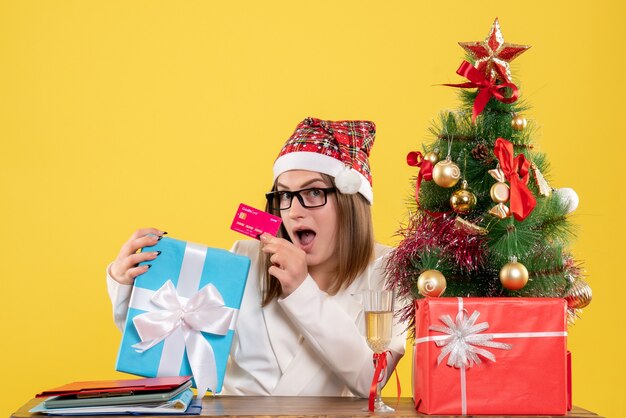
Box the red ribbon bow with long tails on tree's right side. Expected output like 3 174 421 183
493 138 537 221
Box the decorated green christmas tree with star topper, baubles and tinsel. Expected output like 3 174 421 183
387 19 591 334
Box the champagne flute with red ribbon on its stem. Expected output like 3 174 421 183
363 290 394 412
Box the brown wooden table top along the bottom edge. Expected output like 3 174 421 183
11 396 601 418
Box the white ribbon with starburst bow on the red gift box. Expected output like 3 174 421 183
413 298 567 415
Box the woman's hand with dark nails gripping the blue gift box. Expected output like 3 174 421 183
110 228 167 284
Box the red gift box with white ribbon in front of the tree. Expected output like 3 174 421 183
413 298 568 415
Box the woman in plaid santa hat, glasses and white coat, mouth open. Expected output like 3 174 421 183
107 118 406 397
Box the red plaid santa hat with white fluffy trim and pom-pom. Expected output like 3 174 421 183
274 118 376 204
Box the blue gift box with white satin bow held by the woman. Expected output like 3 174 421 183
116 238 250 397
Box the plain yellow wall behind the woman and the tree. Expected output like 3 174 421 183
0 0 626 417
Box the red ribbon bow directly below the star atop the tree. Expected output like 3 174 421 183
444 61 519 122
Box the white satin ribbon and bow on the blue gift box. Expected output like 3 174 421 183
130 243 238 398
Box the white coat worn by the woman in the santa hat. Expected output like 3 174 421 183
107 241 406 397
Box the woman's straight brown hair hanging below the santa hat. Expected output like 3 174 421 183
261 174 374 306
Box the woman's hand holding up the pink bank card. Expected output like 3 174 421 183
260 233 309 297
